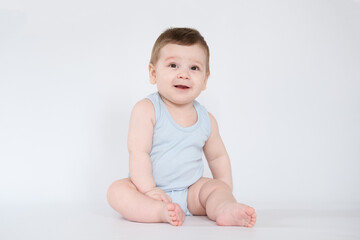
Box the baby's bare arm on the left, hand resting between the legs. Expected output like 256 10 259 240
128 99 171 202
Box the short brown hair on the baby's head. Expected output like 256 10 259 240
150 28 210 74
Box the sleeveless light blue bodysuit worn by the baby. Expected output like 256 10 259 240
147 92 211 215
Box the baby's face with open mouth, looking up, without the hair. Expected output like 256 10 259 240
149 44 209 105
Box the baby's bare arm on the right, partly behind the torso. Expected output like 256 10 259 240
204 113 233 190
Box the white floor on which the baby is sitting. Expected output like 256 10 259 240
0 205 360 240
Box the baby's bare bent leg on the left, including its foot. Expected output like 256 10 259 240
107 178 185 226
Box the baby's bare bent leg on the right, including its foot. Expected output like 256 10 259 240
188 178 256 227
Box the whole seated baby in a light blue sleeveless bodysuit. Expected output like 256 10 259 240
108 28 256 227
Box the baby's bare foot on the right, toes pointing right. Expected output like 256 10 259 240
216 203 256 227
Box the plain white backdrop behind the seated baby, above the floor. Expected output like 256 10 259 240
0 0 360 208
